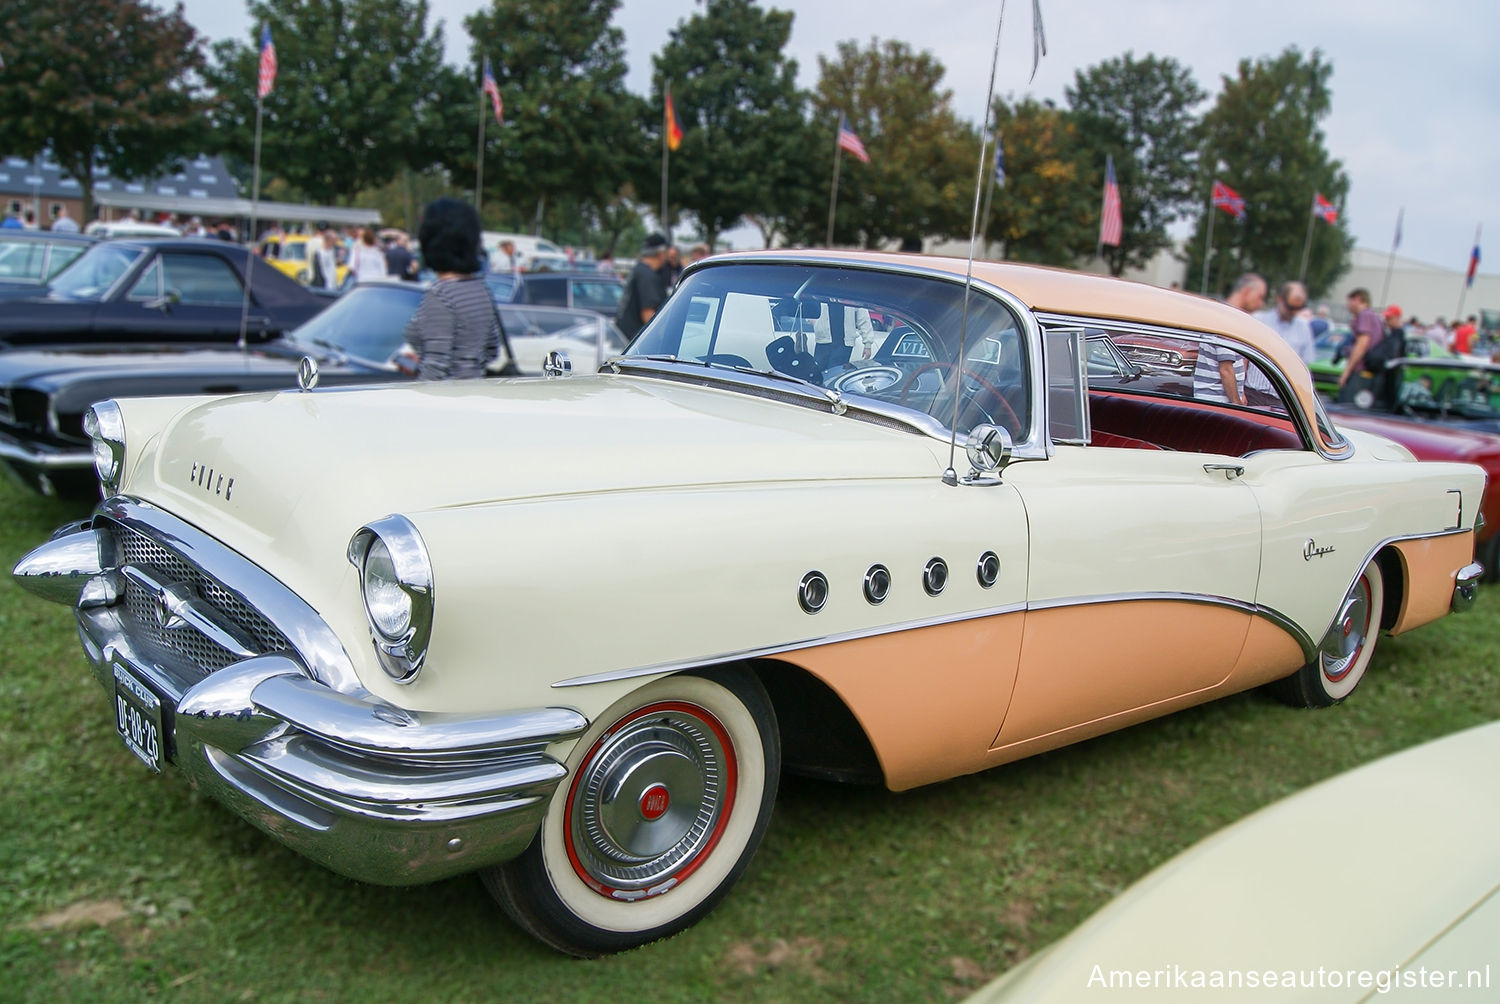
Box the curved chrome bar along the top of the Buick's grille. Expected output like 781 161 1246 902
93 495 369 696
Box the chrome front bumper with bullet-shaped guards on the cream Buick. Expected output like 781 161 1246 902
12 513 588 885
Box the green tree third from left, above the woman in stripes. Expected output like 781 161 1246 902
462 0 648 230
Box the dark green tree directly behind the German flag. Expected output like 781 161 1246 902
636 0 807 246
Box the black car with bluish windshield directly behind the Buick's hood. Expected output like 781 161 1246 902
0 277 626 498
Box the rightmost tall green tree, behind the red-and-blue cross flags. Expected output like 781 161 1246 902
1188 47 1353 296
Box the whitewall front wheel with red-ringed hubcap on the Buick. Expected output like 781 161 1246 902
482 668 782 956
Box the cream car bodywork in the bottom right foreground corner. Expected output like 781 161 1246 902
971 722 1500 1004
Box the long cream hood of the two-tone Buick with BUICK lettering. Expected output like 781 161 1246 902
122 377 947 564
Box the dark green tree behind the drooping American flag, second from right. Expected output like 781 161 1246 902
1065 53 1206 275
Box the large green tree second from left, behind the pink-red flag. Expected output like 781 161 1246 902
207 0 452 204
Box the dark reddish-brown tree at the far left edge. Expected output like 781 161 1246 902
0 0 203 218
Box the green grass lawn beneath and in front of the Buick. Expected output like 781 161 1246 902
0 471 1500 1004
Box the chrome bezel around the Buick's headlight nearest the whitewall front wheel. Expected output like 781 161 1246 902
348 515 434 683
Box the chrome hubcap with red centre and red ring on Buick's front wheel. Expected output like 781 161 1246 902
566 702 735 899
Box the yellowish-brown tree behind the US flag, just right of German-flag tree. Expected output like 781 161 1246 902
797 39 980 248
